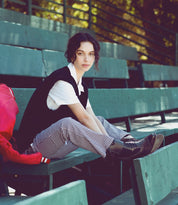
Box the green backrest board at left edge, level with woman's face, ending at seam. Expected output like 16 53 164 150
0 44 45 77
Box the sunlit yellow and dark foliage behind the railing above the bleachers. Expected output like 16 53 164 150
5 0 178 64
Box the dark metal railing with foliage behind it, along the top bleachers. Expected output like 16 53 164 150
0 0 178 65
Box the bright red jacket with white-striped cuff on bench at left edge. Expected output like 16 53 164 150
0 84 50 164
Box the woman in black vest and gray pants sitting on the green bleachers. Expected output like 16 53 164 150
17 33 163 159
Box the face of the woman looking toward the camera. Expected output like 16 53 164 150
73 41 95 73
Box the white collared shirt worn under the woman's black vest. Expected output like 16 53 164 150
47 63 91 110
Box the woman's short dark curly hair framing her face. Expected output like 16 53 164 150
65 32 100 69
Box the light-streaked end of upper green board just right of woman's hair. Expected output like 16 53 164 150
100 42 139 61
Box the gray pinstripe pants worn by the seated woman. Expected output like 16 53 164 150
32 117 128 159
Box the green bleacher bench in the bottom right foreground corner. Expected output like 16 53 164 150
103 142 178 205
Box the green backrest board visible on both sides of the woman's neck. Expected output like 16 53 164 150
42 50 129 79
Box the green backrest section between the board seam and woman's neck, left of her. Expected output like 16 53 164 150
42 50 68 76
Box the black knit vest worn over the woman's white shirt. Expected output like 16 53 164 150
17 67 88 152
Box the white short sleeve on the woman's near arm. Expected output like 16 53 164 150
47 80 79 109
